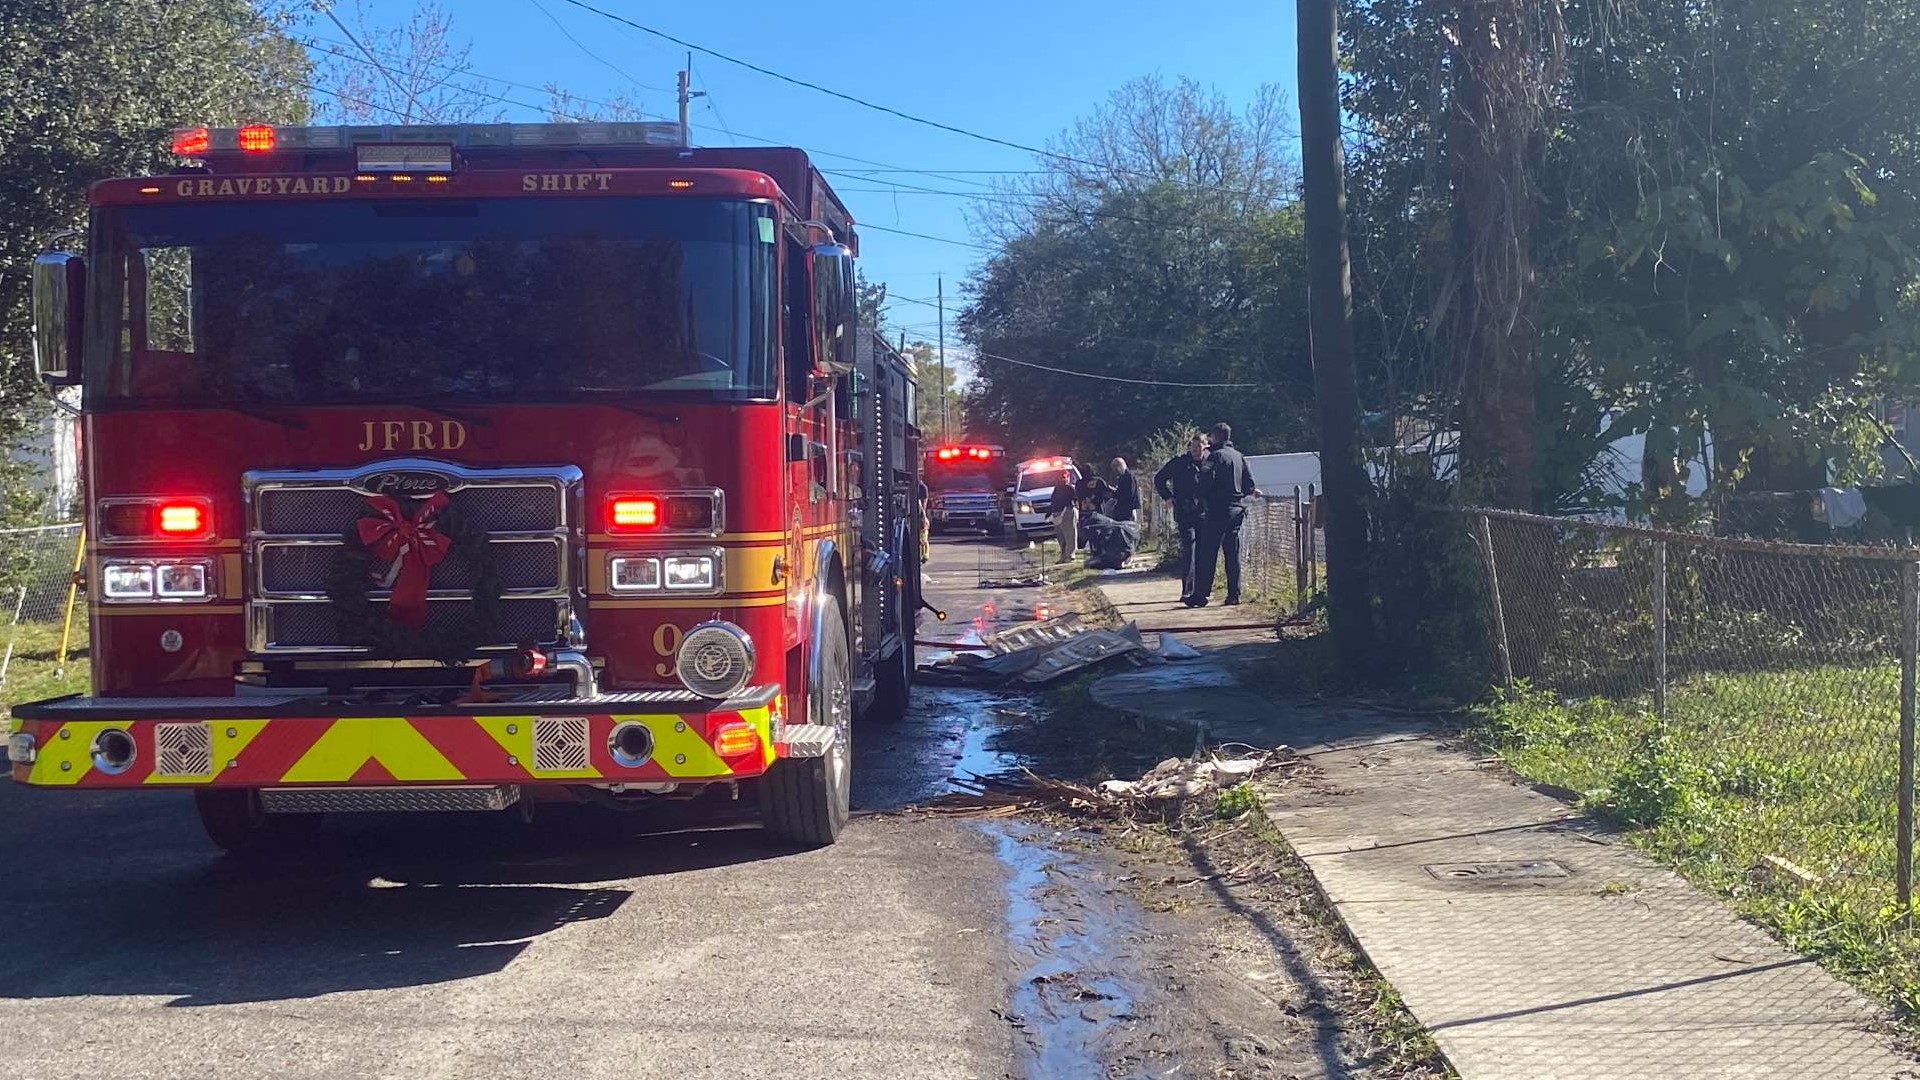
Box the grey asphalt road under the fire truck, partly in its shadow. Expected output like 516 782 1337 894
0 538 1031 1080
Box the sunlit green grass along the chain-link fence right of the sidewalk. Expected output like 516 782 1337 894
1473 665 1920 1026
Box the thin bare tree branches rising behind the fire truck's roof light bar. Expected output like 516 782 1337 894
319 0 505 123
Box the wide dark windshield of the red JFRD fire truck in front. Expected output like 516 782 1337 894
86 198 778 405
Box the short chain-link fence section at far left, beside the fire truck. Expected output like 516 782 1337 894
0 523 86 701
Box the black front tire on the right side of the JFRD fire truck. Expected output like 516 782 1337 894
760 603 852 847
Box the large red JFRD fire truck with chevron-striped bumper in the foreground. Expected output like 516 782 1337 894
8 123 920 849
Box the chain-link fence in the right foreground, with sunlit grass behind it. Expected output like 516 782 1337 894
1467 511 1920 924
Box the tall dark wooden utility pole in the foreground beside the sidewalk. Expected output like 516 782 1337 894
1296 0 1373 669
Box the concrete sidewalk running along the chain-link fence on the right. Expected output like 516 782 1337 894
1094 577 1920 1080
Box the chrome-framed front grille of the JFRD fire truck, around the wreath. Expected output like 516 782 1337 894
246 459 580 655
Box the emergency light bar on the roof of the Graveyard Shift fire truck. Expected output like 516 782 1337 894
173 121 684 160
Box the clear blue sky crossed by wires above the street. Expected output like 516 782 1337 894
311 0 1294 349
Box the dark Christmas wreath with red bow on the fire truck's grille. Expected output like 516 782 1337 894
326 492 501 667
